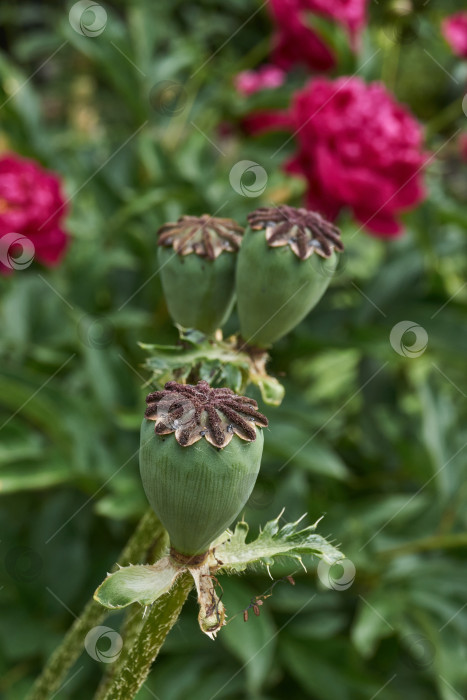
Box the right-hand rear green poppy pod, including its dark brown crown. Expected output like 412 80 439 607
236 205 344 348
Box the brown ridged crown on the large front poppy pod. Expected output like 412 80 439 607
145 381 268 448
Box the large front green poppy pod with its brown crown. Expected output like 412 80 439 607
140 381 268 557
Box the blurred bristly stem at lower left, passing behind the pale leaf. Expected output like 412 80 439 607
28 510 164 700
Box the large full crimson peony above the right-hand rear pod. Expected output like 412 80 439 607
246 77 427 236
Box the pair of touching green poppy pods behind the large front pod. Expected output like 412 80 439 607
158 205 343 348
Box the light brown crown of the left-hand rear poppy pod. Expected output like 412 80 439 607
158 214 243 260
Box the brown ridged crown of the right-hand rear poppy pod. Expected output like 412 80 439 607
248 204 344 260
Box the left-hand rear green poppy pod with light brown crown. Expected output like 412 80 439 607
158 214 243 335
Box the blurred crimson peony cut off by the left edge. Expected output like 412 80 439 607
0 153 68 274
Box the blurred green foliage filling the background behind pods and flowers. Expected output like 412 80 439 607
0 0 467 700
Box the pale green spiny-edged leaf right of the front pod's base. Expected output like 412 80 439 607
215 511 345 571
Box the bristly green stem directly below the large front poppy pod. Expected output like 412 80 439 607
99 573 193 700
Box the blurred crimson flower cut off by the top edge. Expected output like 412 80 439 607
269 0 367 70
